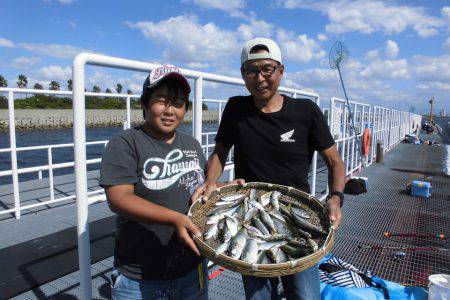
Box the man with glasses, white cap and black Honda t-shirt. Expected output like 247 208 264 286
194 38 345 300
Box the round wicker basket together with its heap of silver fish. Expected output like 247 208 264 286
188 182 334 277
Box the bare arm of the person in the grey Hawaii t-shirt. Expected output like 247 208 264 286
105 184 201 255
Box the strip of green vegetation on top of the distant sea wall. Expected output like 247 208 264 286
0 95 208 110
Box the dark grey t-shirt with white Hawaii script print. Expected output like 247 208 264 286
100 127 206 280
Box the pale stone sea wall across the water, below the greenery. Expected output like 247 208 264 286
0 109 219 131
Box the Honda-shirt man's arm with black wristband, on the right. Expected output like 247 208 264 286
320 145 345 229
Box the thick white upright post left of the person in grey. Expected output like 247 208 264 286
72 54 92 300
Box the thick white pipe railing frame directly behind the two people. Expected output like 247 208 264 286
72 53 319 299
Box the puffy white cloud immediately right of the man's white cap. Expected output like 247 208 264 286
277 28 326 63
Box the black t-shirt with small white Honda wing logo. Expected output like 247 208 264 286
216 95 334 192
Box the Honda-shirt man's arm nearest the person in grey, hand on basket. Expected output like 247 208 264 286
191 142 231 202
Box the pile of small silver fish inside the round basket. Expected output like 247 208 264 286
204 189 327 264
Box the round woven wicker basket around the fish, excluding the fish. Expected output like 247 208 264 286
188 182 334 277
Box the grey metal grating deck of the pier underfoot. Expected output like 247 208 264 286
0 137 450 299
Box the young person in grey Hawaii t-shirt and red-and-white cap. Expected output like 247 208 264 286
100 66 208 300
